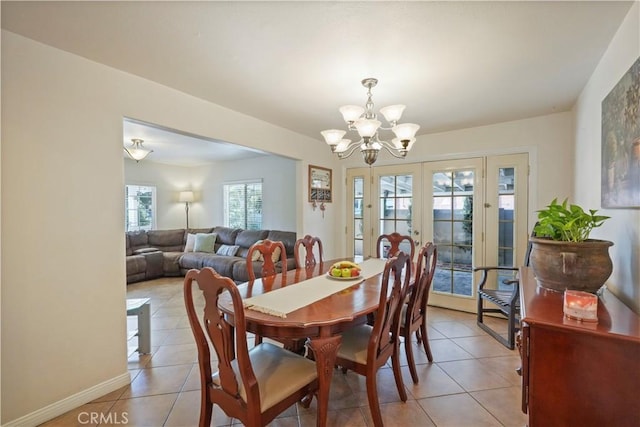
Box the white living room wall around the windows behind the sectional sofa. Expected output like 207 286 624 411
124 156 298 231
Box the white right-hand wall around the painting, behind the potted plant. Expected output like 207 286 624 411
574 2 640 313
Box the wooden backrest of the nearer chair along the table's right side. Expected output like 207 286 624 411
367 251 412 365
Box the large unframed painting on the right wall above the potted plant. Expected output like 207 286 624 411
600 58 640 208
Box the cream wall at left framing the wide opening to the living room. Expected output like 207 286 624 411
0 31 335 425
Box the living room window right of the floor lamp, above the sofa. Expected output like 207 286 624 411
224 181 262 230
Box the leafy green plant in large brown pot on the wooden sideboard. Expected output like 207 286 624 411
530 199 613 293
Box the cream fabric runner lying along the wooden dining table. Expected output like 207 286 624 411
243 258 386 318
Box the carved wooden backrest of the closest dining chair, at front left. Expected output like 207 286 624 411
184 267 260 413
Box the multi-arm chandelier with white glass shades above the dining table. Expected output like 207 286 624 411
320 78 420 165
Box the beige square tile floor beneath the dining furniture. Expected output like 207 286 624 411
42 278 527 427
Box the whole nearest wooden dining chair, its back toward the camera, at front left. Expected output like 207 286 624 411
184 267 318 427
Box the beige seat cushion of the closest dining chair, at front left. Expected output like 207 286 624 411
212 343 317 412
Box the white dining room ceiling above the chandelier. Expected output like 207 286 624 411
1 1 633 166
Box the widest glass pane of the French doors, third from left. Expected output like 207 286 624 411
432 170 474 296
